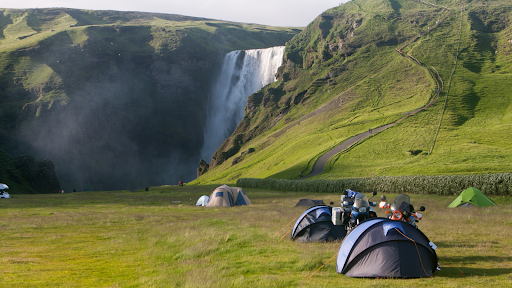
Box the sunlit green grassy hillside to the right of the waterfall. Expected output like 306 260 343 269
194 0 512 183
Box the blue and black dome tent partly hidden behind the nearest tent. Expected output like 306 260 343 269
291 206 347 242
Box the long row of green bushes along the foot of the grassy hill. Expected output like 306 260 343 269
236 173 512 196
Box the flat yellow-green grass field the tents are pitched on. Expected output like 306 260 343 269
0 185 512 287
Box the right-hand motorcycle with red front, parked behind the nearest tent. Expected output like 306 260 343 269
379 194 425 228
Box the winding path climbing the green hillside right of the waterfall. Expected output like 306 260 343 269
296 0 450 180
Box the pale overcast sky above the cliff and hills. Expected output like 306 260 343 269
0 0 348 27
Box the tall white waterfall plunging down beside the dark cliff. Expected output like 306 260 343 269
201 46 284 161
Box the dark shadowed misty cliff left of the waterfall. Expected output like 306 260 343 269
0 9 296 190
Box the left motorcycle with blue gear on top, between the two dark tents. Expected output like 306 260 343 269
341 189 377 232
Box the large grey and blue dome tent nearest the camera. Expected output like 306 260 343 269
336 218 437 278
